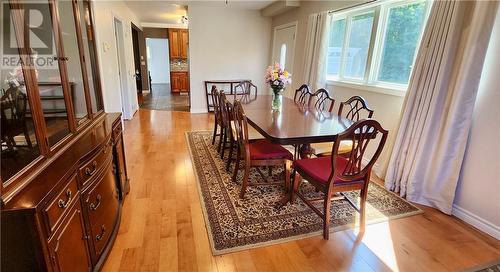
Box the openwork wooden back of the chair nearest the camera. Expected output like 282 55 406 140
329 119 388 184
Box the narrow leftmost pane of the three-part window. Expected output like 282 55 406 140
326 19 345 76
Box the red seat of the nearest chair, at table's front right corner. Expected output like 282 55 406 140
293 156 360 184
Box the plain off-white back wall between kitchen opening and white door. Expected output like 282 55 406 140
188 2 271 112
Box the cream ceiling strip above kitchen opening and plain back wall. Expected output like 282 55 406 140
124 0 276 24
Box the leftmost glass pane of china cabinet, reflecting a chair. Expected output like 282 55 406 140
0 3 40 182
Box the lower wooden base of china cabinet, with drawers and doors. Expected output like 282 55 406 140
1 114 129 271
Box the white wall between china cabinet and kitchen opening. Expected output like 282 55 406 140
92 1 140 119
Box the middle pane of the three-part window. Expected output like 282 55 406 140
344 12 374 79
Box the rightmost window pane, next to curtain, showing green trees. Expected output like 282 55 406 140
378 3 425 84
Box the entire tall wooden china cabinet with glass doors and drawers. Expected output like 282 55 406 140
0 0 129 271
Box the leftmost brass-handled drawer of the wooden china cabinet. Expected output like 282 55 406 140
43 175 78 234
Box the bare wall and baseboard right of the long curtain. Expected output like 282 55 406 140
453 9 500 240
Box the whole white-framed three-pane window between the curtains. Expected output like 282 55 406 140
326 0 430 90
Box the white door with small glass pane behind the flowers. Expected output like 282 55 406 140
273 23 297 74
